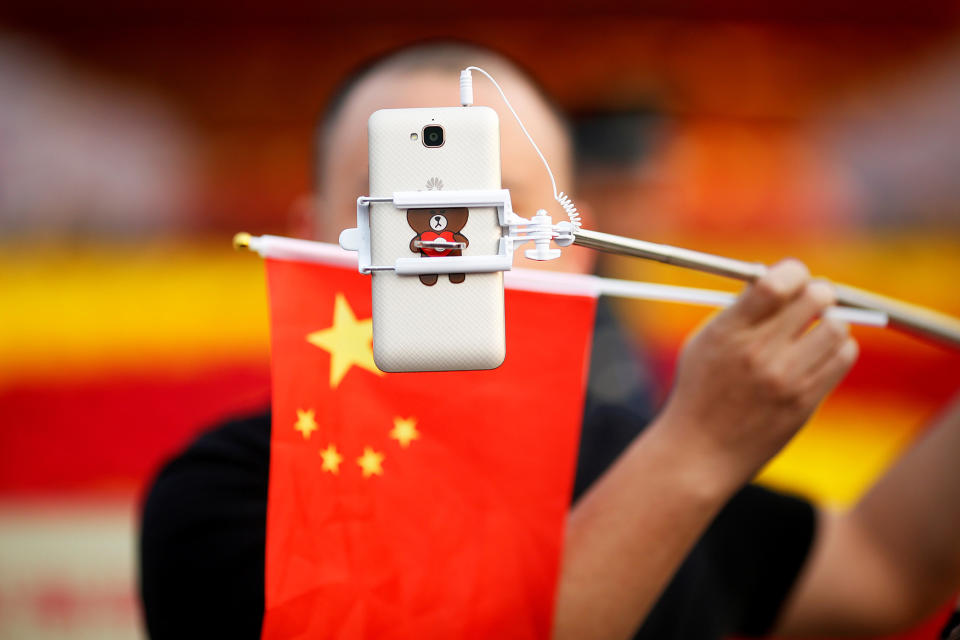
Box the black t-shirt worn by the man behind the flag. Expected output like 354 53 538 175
140 306 815 640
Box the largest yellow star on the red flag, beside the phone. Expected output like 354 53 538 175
307 293 383 389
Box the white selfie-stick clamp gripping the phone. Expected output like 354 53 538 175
340 189 574 275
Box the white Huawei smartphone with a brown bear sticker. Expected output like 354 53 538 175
368 106 506 372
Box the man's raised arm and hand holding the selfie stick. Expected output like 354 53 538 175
554 261 857 638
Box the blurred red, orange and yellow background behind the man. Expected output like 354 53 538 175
0 0 960 638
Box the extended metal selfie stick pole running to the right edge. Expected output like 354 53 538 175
573 229 960 348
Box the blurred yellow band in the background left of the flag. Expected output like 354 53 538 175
0 237 268 384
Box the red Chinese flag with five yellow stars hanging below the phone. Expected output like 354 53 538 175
263 260 595 639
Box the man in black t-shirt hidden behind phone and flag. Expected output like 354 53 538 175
142 45 960 640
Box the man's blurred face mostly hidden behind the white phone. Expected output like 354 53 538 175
315 69 591 271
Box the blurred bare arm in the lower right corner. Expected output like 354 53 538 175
778 392 960 636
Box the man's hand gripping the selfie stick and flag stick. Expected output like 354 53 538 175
658 260 858 483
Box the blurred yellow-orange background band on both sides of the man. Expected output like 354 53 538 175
0 234 960 382
